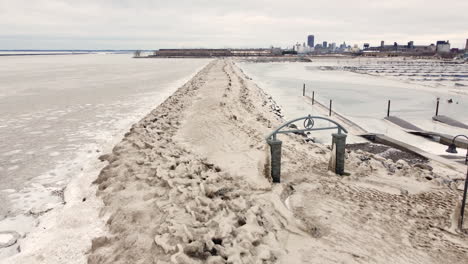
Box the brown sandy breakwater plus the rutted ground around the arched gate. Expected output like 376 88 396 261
88 60 468 263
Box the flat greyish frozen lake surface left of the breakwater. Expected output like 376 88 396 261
0 54 209 258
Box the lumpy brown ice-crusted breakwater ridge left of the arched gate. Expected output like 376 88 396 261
89 60 281 263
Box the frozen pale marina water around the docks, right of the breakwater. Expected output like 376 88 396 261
238 58 468 154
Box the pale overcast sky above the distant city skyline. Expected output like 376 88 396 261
0 0 468 49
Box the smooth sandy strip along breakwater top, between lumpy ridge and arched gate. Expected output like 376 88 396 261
177 62 271 188
